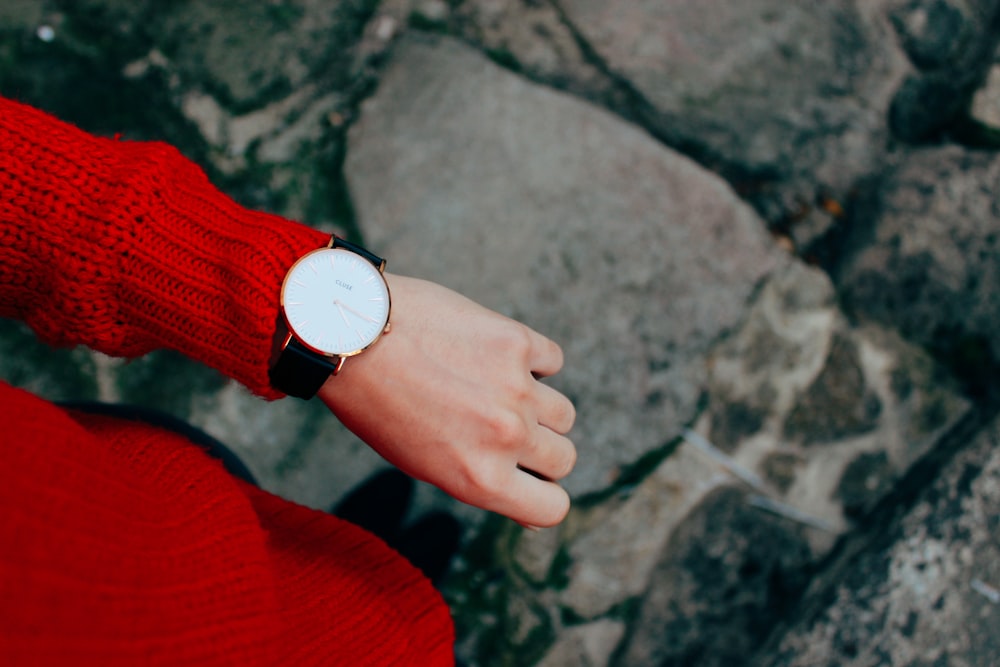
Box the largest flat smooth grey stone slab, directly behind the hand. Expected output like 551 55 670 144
346 37 783 495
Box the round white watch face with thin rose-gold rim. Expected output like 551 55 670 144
281 248 389 357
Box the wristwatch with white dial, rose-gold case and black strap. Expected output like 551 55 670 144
268 236 391 399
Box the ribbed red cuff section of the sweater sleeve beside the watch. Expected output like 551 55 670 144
112 144 330 399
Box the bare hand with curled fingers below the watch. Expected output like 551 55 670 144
319 275 576 526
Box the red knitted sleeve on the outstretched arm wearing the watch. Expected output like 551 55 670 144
0 98 328 398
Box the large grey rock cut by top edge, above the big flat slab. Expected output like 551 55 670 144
560 0 909 218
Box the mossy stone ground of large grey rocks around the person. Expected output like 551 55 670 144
0 0 1000 667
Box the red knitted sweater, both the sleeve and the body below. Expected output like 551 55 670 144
0 99 452 667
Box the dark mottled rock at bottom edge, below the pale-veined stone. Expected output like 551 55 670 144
613 487 810 667
